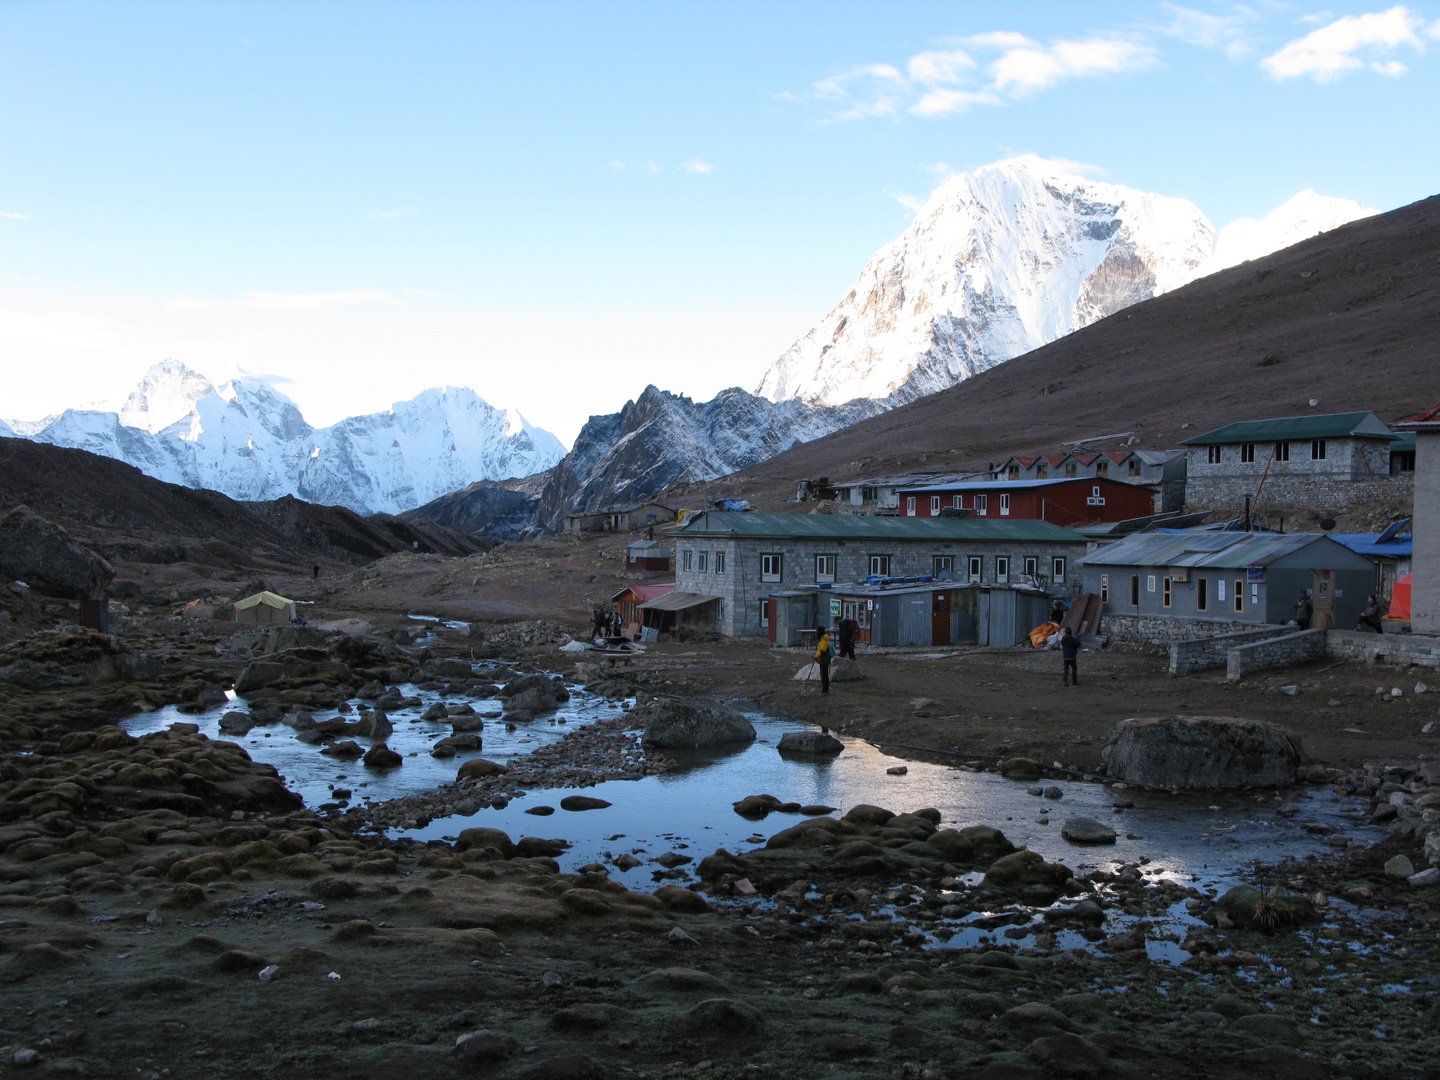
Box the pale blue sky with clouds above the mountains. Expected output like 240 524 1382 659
0 3 1440 441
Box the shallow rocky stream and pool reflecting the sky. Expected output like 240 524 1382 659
124 665 1381 960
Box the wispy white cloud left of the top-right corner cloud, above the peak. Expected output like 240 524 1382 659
800 30 1155 120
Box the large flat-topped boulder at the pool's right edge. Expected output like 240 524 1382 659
1100 716 1305 788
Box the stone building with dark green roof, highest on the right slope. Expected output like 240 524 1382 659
1184 412 1411 517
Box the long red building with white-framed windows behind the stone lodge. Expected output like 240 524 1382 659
900 477 1156 526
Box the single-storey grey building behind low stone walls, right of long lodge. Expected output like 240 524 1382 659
1080 531 1375 641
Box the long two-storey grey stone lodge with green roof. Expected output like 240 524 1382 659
674 511 1087 638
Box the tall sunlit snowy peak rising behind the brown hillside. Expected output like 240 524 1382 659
756 156 1375 406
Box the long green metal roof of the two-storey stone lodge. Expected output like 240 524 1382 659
675 510 1084 544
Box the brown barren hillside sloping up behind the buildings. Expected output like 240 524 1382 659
691 196 1440 508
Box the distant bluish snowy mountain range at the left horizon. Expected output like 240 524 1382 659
8 360 566 514
